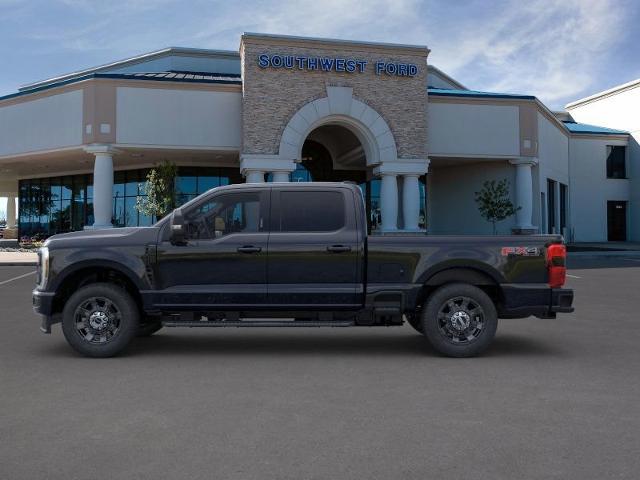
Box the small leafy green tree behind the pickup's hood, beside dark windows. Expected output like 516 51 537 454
136 160 178 220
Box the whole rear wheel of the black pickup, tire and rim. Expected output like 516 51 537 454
422 283 498 357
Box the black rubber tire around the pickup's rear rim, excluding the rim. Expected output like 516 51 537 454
422 283 498 357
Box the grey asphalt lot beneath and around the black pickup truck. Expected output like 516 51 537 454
0 257 640 480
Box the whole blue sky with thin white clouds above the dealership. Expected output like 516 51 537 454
0 0 640 109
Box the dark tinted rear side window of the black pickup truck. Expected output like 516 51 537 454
280 191 344 232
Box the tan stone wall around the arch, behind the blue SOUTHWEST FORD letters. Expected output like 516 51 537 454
240 34 429 159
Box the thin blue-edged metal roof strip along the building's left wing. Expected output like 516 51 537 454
0 71 242 100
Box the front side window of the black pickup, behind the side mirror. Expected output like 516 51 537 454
185 193 263 239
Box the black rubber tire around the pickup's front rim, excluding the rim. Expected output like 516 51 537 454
62 283 140 358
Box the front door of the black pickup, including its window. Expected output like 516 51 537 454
155 189 270 310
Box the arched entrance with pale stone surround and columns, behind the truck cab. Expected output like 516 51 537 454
240 86 429 232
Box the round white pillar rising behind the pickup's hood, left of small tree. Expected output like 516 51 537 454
84 145 117 229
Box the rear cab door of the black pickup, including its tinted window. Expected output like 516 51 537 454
267 185 363 309
